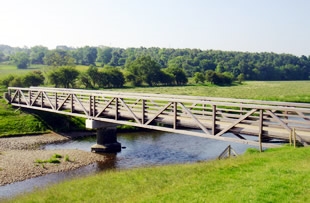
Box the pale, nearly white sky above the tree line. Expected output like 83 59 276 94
0 0 310 56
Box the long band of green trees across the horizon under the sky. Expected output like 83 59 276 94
0 45 310 88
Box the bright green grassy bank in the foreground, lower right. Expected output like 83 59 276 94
12 147 310 202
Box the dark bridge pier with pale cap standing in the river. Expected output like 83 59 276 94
86 120 121 153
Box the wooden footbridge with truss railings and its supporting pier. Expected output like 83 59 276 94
5 87 310 151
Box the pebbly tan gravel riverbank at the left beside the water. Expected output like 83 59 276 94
0 133 105 186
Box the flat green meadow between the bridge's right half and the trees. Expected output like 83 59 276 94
114 81 310 102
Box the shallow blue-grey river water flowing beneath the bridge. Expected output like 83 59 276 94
0 131 252 200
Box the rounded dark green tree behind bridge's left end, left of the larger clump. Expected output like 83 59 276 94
48 66 79 88
